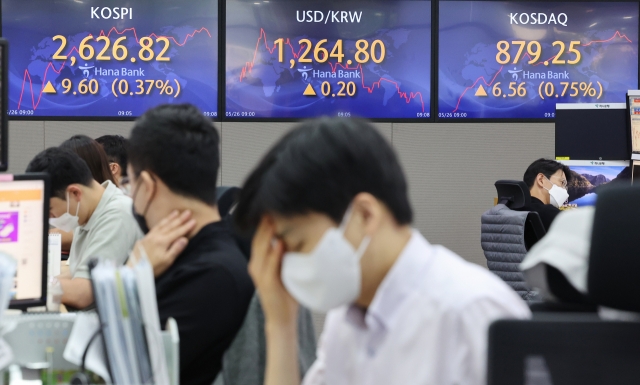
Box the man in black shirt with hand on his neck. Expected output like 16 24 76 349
128 105 254 385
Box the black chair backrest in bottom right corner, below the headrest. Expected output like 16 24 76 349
487 315 640 385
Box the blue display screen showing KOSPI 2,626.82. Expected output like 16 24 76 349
2 0 218 117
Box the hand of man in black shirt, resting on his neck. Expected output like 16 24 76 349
129 210 196 277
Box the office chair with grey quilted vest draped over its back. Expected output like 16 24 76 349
481 180 545 302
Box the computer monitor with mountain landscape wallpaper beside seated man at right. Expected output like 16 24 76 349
560 160 631 207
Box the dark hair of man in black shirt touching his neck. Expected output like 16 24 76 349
128 104 220 206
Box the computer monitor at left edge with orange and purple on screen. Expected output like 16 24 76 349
0 173 49 309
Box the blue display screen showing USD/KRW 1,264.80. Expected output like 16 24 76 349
225 0 431 120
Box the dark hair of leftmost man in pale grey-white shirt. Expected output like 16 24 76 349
27 147 93 200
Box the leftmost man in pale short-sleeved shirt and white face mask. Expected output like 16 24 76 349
27 147 142 309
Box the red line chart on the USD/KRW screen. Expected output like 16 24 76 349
240 28 424 112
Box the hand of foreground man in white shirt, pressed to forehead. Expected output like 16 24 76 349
249 217 298 326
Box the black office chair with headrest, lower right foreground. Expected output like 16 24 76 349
488 187 640 385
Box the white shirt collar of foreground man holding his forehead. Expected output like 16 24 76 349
347 230 433 330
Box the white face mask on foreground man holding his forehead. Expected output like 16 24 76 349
281 208 371 313
